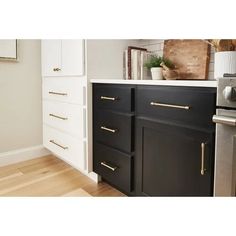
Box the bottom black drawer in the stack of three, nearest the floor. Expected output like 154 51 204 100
93 143 132 193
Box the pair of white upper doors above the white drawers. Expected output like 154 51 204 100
42 39 84 76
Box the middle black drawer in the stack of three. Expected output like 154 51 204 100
93 111 134 152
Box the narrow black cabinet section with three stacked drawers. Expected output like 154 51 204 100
93 84 135 195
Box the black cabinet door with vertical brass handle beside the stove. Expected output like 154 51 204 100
136 118 214 196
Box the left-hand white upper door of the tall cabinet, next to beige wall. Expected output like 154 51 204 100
41 39 62 76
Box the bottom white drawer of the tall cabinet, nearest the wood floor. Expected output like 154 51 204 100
43 125 85 169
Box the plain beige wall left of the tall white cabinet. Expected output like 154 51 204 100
0 40 42 153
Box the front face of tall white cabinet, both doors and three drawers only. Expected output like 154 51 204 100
41 40 88 171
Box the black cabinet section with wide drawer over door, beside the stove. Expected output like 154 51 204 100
135 86 216 196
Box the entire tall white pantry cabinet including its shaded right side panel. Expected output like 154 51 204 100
41 39 134 178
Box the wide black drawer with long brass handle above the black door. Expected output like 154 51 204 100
136 86 216 128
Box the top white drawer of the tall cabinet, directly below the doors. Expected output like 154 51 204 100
43 77 85 105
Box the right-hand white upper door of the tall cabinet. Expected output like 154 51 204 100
62 39 84 76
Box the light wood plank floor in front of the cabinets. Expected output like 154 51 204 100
0 155 125 197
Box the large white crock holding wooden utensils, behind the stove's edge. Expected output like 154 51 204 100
214 51 236 79
